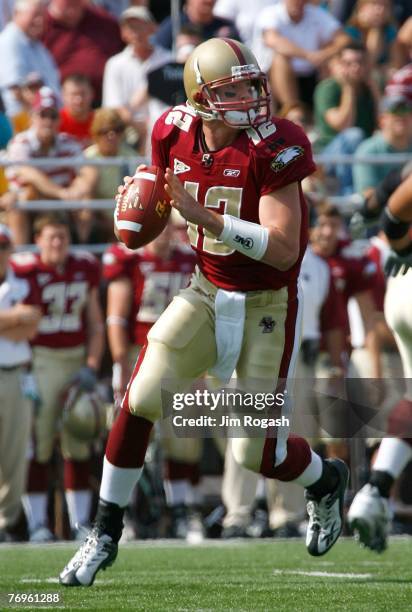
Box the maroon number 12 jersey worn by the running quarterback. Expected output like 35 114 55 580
152 105 315 291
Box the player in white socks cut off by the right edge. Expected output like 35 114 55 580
348 174 412 552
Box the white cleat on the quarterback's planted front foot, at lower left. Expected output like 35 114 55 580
59 526 118 586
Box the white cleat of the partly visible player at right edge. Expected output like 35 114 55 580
348 484 392 552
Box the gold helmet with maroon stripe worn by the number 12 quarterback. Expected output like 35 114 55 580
183 38 270 128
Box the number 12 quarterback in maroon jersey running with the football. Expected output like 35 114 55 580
60 38 348 586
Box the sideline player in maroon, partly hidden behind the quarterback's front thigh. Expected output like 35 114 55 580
103 222 201 537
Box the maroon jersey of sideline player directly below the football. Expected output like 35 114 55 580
103 244 195 346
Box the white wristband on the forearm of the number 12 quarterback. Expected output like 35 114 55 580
219 215 269 260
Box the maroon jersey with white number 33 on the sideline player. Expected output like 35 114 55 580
11 252 100 349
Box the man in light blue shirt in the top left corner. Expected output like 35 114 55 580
0 0 60 115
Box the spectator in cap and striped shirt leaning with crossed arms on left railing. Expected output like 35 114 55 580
7 87 84 244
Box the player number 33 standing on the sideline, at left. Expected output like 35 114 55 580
14 213 104 541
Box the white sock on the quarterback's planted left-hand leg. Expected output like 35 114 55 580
100 457 143 508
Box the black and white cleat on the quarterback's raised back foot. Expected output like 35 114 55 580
305 459 349 557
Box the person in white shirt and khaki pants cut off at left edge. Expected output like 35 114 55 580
0 225 41 542
